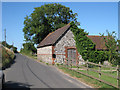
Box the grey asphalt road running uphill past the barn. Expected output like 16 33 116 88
4 54 90 88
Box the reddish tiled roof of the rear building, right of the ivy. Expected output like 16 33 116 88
87 35 107 50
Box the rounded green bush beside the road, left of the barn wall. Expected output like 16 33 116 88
20 43 37 55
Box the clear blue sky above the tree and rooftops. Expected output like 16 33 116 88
2 2 118 50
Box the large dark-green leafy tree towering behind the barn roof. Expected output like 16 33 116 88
23 3 79 44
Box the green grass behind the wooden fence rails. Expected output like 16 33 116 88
64 65 117 86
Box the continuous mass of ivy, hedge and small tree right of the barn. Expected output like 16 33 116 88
70 22 120 64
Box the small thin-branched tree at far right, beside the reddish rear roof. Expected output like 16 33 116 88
100 30 119 63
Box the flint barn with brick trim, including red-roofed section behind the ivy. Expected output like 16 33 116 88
37 24 104 64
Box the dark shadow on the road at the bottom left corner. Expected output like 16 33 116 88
3 81 32 90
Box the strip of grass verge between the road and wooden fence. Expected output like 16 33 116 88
58 65 117 90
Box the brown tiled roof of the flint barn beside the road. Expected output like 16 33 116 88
37 24 70 48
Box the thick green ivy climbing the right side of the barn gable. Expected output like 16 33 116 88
70 22 95 60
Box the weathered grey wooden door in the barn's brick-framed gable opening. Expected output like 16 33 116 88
67 48 76 65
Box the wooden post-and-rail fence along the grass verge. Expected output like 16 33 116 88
64 60 120 89
